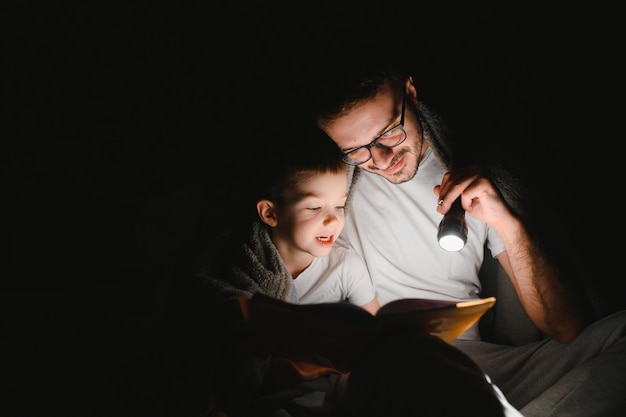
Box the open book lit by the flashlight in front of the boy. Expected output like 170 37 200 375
239 294 496 370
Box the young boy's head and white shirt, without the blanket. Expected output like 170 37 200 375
251 123 379 314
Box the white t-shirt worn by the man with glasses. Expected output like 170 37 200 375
340 149 504 339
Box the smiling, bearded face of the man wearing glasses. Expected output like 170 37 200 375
323 82 426 184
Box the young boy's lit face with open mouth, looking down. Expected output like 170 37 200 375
272 170 348 257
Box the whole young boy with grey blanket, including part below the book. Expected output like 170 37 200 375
196 123 380 416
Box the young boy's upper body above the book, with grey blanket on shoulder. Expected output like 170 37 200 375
199 118 380 314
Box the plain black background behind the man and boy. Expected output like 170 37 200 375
0 1 625 415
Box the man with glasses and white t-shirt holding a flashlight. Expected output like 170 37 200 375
302 47 626 416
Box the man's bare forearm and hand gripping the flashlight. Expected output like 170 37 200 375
434 166 592 343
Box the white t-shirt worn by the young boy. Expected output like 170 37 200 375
293 237 375 305
